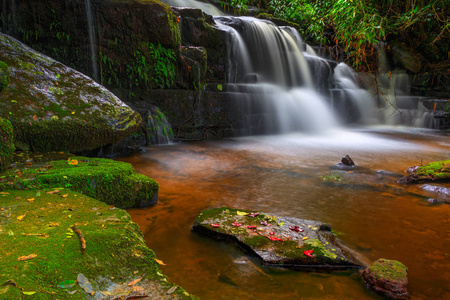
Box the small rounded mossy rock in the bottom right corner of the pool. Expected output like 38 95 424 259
362 258 409 299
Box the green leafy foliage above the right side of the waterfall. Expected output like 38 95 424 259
223 0 450 71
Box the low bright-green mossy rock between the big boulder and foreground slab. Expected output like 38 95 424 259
0 157 159 208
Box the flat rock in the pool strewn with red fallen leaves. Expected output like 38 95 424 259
193 207 366 271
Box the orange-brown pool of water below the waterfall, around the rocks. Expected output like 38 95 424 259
121 128 450 299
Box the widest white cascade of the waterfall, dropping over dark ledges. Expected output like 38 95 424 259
215 17 338 135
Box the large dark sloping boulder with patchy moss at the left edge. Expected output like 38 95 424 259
0 34 141 152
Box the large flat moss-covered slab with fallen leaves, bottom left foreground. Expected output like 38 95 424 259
0 189 193 300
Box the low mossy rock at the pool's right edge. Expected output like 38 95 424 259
399 160 450 183
